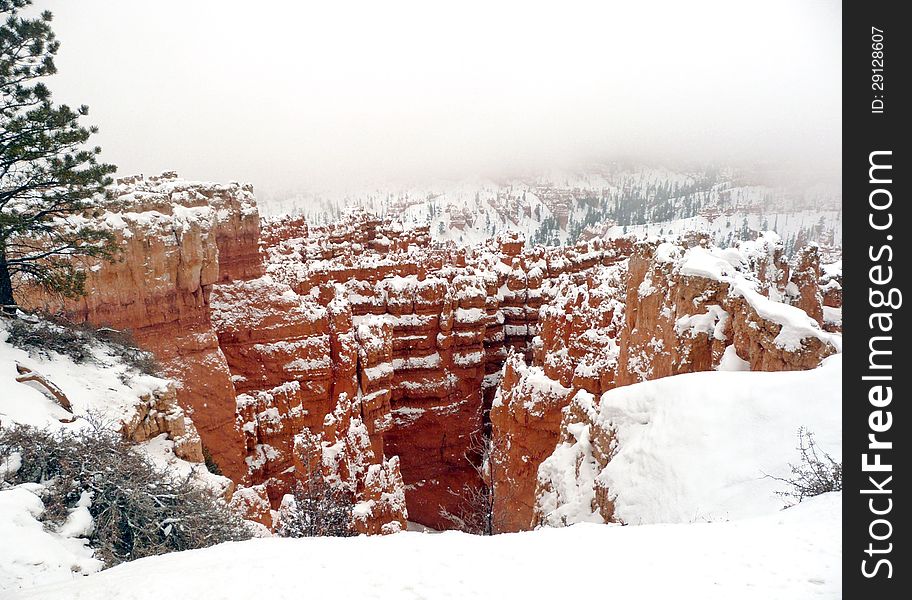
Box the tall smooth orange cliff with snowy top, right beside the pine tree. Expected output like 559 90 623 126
21 173 247 481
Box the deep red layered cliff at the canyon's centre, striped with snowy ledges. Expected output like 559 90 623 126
266 215 626 528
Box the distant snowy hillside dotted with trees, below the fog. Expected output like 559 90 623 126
259 164 842 256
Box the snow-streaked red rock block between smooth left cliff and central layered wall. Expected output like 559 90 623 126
212 278 334 492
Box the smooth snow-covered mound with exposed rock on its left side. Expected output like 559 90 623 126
536 355 842 525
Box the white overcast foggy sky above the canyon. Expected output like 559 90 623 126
41 0 841 193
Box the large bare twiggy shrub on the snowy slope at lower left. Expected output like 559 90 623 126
0 422 251 567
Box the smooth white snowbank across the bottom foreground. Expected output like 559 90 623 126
10 493 842 600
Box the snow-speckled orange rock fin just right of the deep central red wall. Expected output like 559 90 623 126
490 261 627 531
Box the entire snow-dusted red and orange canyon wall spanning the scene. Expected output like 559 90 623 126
17 173 841 533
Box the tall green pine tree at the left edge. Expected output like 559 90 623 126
0 0 116 312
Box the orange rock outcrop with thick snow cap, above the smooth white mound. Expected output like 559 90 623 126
616 234 840 385
